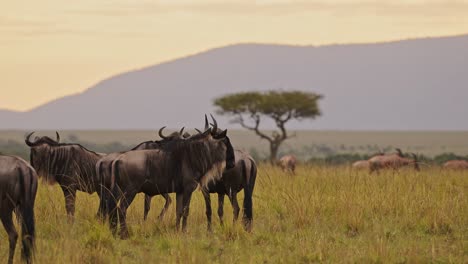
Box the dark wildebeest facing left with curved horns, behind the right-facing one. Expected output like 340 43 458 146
25 132 105 217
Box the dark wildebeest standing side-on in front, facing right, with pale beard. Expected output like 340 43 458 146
109 122 235 238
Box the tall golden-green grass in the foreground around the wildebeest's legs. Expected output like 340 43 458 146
0 165 468 263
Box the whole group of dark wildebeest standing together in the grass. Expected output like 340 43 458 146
0 115 257 263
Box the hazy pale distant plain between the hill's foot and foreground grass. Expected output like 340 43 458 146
0 129 468 160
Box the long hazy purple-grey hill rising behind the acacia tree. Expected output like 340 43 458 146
0 35 468 130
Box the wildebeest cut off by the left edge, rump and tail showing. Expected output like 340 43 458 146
0 155 37 263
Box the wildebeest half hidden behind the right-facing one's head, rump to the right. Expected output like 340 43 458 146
145 116 257 231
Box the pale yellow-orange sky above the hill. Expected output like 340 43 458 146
0 0 468 111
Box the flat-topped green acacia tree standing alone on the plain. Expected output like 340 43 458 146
214 91 323 162
